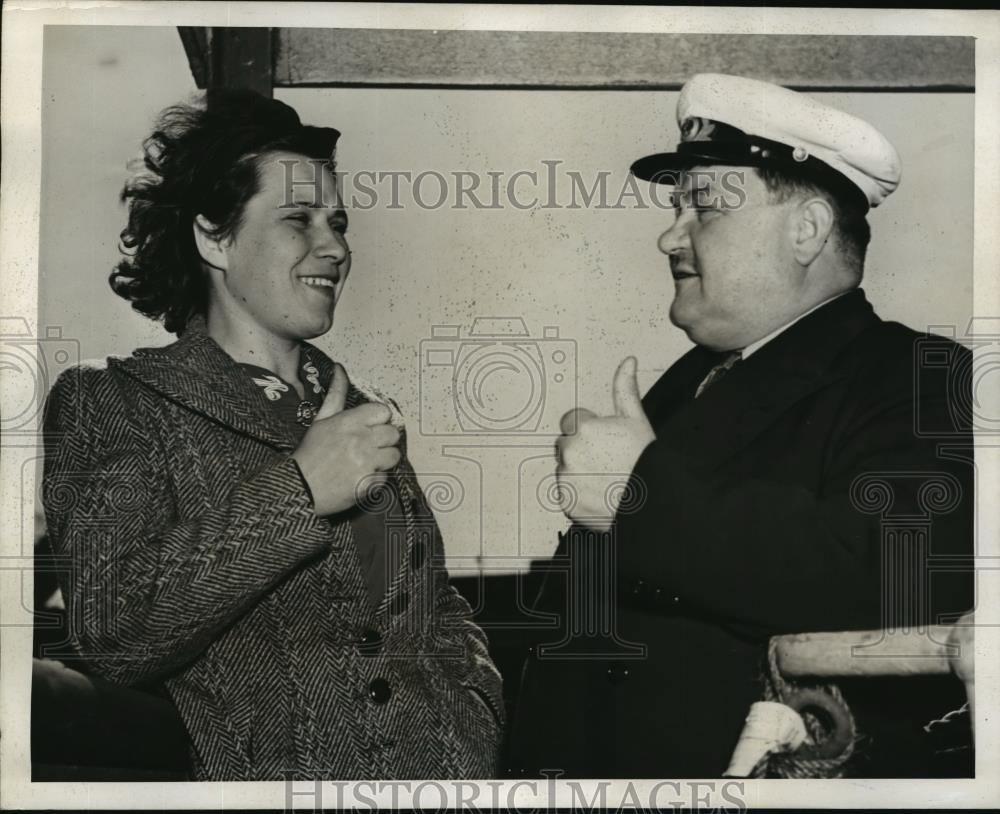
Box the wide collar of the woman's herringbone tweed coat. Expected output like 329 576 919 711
109 317 364 450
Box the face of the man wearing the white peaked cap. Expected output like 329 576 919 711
659 166 804 350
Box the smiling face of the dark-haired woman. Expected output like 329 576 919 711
215 152 351 340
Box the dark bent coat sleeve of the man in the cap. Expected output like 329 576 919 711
614 344 974 635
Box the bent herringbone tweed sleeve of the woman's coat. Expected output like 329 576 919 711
42 369 329 684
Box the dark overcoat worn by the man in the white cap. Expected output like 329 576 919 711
510 290 974 778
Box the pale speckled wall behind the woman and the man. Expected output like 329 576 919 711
39 27 974 569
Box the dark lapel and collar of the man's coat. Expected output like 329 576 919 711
651 289 878 471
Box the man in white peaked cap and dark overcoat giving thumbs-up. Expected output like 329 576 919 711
509 74 973 777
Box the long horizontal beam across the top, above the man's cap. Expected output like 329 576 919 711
274 28 975 91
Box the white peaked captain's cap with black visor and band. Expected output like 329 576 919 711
632 73 901 206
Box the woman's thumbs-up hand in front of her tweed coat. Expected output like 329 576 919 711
292 364 400 515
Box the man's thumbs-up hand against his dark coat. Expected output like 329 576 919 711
556 356 656 531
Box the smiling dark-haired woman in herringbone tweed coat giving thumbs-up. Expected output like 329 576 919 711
43 91 503 780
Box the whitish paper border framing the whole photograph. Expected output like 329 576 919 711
0 2 1000 809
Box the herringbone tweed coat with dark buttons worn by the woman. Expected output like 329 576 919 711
43 321 503 780
